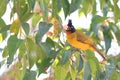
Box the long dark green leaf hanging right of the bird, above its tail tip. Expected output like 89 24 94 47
103 26 112 53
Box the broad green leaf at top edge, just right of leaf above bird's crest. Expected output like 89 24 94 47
70 0 82 13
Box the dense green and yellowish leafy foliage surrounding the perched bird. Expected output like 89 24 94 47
0 0 120 80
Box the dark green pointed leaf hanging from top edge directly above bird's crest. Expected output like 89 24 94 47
61 0 70 18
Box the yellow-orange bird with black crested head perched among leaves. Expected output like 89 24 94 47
65 20 106 61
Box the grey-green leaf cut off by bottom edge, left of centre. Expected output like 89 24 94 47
23 70 37 80
